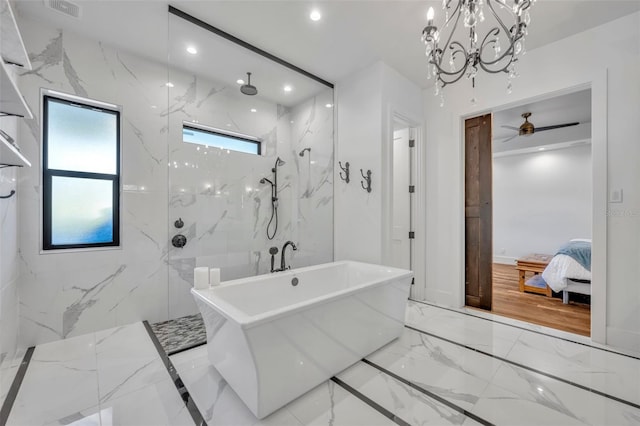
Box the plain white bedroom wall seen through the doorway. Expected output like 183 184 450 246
492 144 592 263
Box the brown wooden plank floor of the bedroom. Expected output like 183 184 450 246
492 263 591 336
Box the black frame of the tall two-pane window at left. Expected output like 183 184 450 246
42 92 122 250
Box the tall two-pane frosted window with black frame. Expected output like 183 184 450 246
42 92 120 250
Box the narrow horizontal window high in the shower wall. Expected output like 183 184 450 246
182 123 261 155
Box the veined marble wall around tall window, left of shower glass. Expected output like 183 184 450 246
18 19 168 346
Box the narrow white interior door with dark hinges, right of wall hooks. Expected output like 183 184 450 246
391 128 411 269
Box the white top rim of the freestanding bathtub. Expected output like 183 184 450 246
191 260 414 330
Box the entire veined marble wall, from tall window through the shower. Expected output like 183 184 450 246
15 11 334 353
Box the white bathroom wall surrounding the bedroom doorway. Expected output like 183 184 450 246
424 13 640 350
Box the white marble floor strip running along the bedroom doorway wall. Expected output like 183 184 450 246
407 302 640 405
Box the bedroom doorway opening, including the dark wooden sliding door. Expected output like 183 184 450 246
465 89 593 336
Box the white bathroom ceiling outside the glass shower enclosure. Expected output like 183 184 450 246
16 0 640 87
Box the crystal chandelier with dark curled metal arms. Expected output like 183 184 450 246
422 0 535 104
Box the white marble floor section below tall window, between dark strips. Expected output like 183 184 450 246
7 323 194 426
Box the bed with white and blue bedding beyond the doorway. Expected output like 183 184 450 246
542 238 591 304
